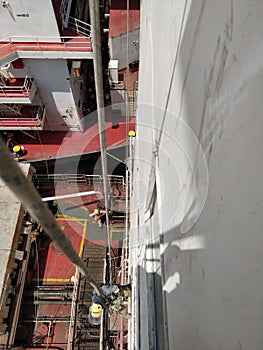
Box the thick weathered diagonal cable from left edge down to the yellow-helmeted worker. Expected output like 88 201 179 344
0 137 108 309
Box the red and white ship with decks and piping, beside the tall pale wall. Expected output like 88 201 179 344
0 0 140 349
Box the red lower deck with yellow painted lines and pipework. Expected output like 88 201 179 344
16 179 127 349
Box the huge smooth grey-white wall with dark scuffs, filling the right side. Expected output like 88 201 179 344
131 0 263 350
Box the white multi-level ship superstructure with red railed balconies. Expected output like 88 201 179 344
0 0 92 131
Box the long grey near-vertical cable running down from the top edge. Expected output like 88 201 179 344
89 0 111 284
